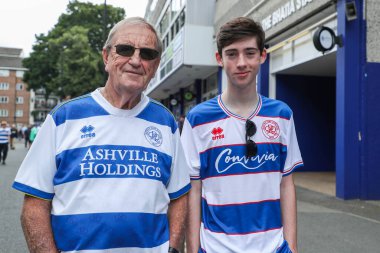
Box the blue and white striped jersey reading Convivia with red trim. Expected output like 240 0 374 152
181 96 303 253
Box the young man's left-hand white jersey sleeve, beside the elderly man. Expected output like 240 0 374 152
181 119 200 180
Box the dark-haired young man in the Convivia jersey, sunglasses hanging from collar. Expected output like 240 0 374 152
181 18 302 253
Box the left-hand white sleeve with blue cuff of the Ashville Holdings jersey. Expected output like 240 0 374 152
12 114 57 200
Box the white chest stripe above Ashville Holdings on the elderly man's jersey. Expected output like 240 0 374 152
56 115 173 154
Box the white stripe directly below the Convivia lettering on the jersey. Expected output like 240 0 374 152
202 172 282 205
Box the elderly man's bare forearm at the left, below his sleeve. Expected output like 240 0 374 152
21 195 58 253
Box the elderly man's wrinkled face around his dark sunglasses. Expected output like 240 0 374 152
103 24 160 93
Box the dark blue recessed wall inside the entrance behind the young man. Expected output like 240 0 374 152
276 75 335 171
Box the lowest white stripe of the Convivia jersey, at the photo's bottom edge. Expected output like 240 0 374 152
200 223 284 253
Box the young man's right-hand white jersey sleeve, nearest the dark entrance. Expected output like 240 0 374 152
283 115 303 176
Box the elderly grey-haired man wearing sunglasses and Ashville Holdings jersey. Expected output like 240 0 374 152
13 18 190 253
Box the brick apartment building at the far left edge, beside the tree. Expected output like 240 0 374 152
0 47 30 129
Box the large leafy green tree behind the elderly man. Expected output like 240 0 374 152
23 1 125 98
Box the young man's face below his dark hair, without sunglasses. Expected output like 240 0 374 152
216 37 266 89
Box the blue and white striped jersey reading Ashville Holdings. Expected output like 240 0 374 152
13 90 190 253
